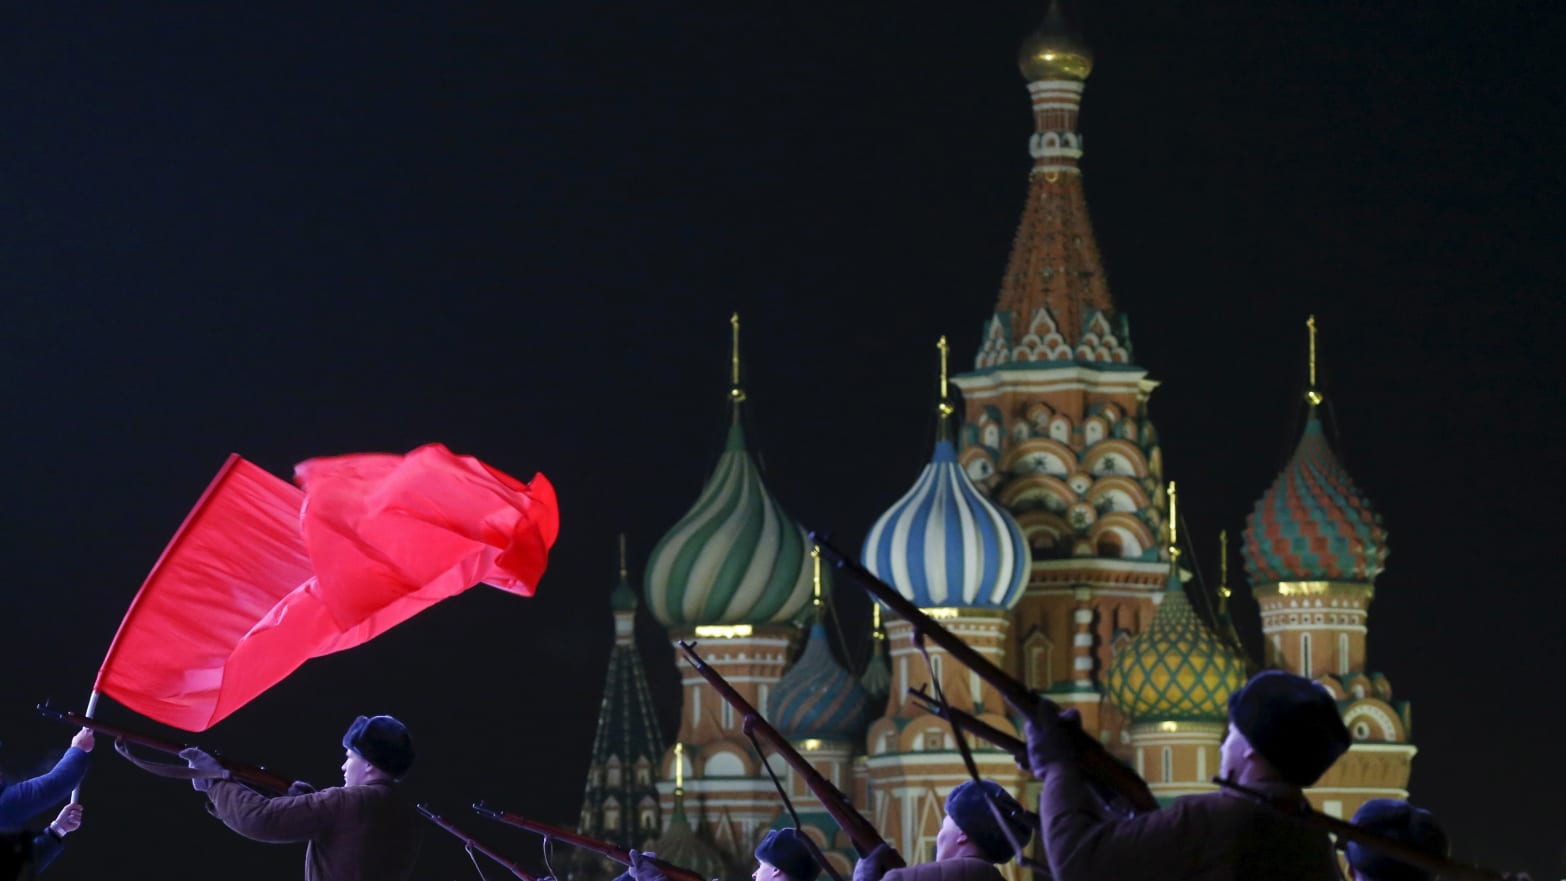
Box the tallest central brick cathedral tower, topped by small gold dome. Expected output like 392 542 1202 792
955 0 1167 756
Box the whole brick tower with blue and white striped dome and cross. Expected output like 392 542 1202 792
861 338 1029 881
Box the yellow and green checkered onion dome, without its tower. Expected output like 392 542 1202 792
1107 566 1245 723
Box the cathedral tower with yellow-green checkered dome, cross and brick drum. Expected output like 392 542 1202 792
1107 482 1245 803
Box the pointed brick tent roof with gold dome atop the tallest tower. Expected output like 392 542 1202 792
974 0 1132 369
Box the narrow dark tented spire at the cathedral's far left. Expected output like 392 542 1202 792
573 535 664 878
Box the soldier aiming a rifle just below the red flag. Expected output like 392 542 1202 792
180 715 423 881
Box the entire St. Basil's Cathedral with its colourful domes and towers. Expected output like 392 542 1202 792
570 5 1416 881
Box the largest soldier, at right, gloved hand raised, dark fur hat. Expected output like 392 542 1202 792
1027 670 1350 881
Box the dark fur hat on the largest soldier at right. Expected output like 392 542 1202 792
1229 670 1350 786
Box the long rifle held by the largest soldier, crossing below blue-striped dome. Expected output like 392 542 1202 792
810 532 1159 814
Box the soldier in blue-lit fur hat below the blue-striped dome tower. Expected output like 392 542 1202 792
853 779 1032 881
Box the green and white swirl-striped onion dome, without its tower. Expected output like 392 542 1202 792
647 421 830 627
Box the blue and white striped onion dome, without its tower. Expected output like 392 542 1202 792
860 440 1032 609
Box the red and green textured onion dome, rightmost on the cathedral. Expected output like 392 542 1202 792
1245 407 1387 584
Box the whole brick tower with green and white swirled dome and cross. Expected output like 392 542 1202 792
647 315 830 878
